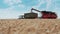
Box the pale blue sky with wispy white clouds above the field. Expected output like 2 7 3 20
0 0 60 19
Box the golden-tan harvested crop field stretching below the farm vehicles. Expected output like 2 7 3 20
0 19 60 34
